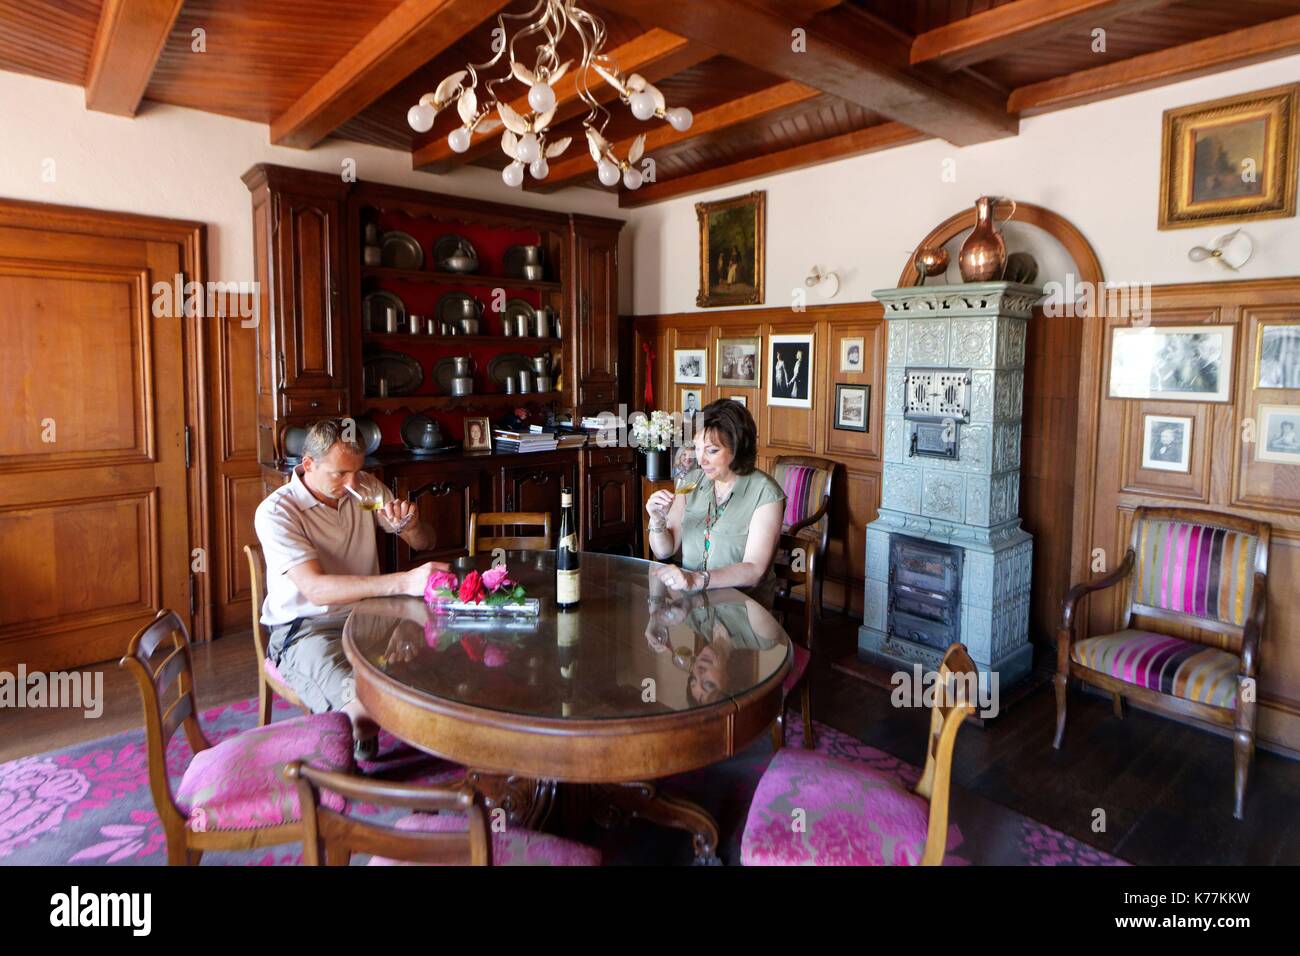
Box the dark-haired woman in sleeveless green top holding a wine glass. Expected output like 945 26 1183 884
646 398 785 607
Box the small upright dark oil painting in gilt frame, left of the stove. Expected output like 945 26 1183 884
696 191 767 308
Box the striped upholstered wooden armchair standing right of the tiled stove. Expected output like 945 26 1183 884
1053 507 1270 819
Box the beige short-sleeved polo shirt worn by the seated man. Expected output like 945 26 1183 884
254 466 393 627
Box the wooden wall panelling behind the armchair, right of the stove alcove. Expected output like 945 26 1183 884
1073 278 1300 753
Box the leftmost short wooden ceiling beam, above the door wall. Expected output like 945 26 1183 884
86 0 185 116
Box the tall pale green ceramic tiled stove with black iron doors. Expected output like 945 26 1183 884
858 282 1043 689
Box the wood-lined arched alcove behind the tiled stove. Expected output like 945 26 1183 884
898 203 1104 645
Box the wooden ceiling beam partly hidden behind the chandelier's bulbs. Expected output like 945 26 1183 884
411 30 714 173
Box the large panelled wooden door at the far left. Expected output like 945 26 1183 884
0 203 205 670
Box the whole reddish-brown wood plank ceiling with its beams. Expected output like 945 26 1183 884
0 0 1300 206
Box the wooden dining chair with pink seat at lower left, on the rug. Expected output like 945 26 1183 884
118 609 355 865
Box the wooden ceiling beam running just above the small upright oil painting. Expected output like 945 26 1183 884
619 122 930 208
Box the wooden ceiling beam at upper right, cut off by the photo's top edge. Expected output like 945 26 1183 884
910 0 1171 72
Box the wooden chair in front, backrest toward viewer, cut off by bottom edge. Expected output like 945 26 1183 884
283 761 601 866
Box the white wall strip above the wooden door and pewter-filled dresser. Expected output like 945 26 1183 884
0 73 627 282
